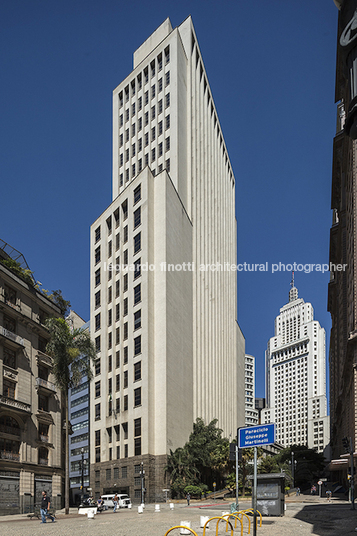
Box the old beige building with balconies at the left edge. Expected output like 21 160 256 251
0 243 64 515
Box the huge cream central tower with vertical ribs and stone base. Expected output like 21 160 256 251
90 17 244 500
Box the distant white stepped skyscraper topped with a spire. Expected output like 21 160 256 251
262 281 330 452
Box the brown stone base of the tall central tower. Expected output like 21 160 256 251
90 454 169 504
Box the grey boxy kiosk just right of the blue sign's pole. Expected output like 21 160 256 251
250 473 285 516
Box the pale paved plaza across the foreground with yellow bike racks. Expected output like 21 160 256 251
0 496 357 536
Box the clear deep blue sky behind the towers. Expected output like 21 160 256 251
0 0 338 402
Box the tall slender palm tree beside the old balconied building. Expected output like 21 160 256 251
46 318 96 514
